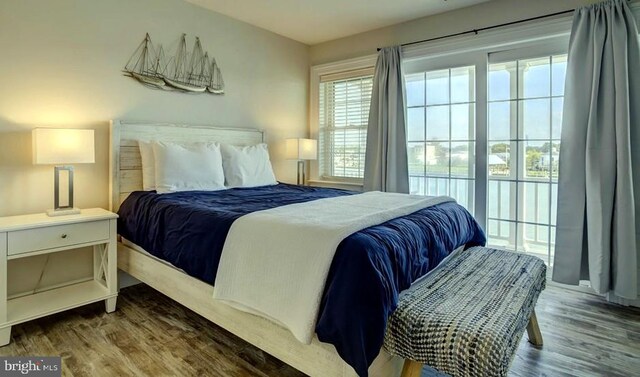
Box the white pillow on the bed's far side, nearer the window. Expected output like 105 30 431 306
221 144 278 187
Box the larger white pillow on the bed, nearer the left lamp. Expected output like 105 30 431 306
152 142 225 194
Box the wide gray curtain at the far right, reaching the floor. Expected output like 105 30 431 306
553 0 640 300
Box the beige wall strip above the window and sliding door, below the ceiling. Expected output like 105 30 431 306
310 0 599 65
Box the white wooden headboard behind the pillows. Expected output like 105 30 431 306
109 120 266 212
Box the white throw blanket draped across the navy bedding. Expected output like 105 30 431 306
213 192 453 344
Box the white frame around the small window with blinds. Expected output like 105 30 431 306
309 55 377 189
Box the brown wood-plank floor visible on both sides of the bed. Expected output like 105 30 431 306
0 285 640 377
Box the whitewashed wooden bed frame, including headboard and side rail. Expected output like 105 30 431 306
109 120 403 377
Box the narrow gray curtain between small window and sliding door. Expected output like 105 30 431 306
364 46 409 193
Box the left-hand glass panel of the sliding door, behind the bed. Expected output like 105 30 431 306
406 66 475 213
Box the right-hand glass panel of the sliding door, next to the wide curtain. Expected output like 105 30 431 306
487 55 567 263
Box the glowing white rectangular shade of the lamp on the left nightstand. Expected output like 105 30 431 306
31 128 96 165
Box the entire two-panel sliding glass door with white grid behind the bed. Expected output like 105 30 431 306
405 43 566 264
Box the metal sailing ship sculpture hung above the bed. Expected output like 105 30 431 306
124 33 224 94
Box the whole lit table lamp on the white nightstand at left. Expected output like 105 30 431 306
31 128 95 216
